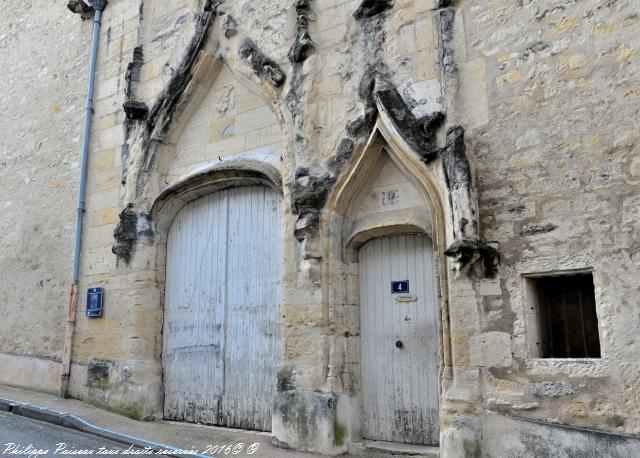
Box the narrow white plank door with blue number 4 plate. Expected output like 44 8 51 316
360 235 439 445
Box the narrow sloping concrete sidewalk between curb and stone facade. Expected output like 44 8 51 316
0 385 330 458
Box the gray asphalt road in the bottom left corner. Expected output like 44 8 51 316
0 412 138 458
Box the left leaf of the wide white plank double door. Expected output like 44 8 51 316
163 191 228 424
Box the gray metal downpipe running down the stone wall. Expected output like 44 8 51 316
59 0 107 398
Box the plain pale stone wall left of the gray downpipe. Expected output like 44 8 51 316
0 2 90 391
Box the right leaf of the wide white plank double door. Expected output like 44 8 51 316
222 186 282 431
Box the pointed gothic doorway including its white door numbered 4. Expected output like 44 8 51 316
329 119 451 446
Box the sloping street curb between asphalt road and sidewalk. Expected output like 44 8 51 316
0 397 210 458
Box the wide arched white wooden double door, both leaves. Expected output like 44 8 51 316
163 186 282 431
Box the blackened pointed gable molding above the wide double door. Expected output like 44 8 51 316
125 7 286 207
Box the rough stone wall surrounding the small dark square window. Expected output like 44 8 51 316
460 1 640 434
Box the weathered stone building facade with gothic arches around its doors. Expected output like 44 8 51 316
0 0 640 457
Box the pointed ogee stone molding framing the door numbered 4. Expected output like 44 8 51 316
322 113 453 404
